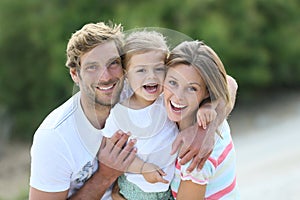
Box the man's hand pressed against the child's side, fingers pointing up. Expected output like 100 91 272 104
98 131 137 182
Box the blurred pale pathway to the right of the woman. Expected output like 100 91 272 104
230 93 300 200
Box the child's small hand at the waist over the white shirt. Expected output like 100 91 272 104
142 163 169 184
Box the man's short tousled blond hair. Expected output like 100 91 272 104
66 22 124 69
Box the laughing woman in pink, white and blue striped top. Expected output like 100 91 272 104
164 41 238 200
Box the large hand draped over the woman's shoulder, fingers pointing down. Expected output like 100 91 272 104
171 124 215 172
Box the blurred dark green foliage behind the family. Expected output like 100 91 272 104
0 0 300 139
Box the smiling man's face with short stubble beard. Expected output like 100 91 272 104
73 41 124 106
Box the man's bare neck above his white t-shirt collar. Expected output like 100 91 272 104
80 99 111 129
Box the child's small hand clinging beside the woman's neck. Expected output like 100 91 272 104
197 104 217 129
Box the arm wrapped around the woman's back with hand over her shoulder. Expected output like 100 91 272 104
171 76 238 171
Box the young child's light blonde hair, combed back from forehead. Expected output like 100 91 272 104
123 30 169 68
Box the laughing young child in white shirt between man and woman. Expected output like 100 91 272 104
102 31 178 200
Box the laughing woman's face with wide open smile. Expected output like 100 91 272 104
164 64 209 128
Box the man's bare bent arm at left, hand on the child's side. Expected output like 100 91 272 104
29 132 136 200
